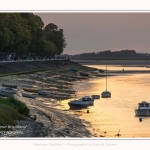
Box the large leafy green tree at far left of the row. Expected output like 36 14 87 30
0 13 30 55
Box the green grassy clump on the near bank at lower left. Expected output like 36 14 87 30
0 97 30 130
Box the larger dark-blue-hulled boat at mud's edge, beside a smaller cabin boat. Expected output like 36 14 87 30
68 100 89 109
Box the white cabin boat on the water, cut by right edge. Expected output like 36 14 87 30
135 101 150 116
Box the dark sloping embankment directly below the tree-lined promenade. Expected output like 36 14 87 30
0 60 79 75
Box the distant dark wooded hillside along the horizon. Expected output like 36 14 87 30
71 50 149 58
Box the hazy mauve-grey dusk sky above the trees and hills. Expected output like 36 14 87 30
34 12 150 55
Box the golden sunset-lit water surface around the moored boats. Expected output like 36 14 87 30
58 65 150 138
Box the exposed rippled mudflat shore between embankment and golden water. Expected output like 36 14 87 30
0 61 102 138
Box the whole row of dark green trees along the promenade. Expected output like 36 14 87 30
0 13 66 57
